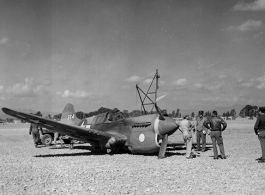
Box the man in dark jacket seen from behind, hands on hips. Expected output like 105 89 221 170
204 110 227 159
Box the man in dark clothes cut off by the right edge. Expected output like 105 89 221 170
254 107 265 163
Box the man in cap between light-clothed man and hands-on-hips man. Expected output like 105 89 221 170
196 110 207 152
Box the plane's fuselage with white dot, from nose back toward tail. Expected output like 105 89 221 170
80 113 177 153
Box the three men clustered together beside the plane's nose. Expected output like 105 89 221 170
176 111 227 159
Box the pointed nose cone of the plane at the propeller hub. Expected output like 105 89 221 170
158 118 179 135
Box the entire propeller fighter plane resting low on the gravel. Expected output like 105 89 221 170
2 104 178 158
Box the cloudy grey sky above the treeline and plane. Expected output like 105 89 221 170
0 0 265 113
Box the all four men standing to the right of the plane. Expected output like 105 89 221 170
176 107 265 163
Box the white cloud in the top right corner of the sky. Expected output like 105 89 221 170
233 0 265 11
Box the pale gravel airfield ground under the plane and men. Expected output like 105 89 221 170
0 120 265 194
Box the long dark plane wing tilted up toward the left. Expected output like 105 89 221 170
2 108 127 142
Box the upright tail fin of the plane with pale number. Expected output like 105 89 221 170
60 103 81 125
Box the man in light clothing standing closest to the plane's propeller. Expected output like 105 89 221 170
176 115 196 159
